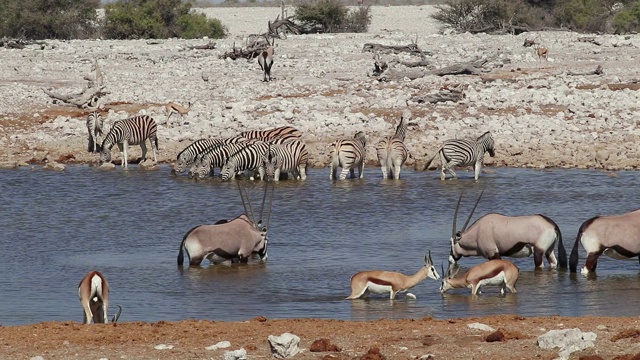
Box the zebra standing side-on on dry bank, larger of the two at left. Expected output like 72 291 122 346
100 115 158 169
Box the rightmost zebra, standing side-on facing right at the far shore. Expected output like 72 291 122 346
424 131 496 180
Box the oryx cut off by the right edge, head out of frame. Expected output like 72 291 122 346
569 209 640 274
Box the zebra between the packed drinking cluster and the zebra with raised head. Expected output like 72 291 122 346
329 131 367 180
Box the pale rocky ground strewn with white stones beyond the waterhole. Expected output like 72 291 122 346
0 6 640 170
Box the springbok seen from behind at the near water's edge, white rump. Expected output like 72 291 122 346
78 270 122 324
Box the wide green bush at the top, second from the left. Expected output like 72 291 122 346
103 0 226 39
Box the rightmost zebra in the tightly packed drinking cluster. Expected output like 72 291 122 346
258 140 309 181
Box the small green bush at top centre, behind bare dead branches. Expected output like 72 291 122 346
295 0 371 33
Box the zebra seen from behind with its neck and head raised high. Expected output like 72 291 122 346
376 110 411 180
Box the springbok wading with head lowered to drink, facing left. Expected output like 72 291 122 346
440 259 520 295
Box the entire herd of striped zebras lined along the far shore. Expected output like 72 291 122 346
87 110 495 181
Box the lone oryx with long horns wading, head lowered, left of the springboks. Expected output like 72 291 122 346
178 181 274 266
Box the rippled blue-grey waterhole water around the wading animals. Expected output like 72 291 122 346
0 166 640 325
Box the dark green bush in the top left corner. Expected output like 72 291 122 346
0 0 100 39
